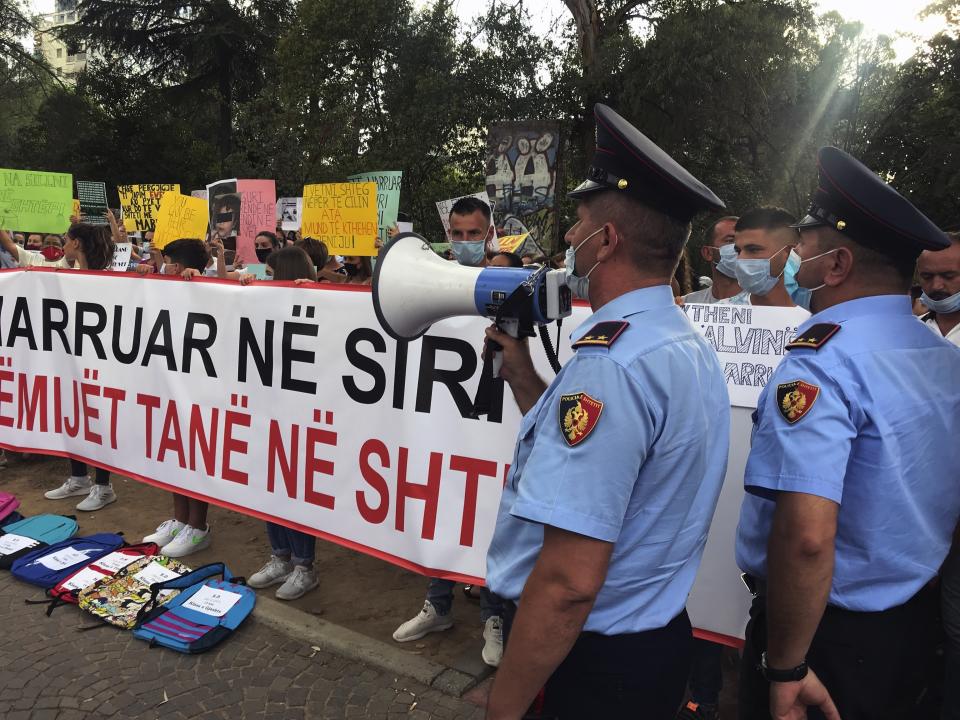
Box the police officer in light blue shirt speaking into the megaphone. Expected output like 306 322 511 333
487 105 729 720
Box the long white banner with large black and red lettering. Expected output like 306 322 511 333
0 270 800 637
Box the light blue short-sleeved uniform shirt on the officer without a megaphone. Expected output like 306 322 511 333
737 295 960 611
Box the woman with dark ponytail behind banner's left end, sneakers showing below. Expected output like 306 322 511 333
0 223 117 512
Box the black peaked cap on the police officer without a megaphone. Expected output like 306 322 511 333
793 147 950 256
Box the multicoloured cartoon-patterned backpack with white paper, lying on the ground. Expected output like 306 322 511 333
77 555 190 630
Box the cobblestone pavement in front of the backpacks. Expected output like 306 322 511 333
0 571 483 720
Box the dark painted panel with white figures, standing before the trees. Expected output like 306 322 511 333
486 120 563 256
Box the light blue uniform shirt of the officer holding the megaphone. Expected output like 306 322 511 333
487 286 728 635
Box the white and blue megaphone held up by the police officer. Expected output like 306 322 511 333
373 232 572 340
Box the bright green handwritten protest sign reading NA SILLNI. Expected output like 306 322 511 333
0 168 73 233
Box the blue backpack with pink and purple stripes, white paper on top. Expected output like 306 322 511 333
133 563 257 654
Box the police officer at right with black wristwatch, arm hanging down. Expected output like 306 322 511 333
736 147 960 720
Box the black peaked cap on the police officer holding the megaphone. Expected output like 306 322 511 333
569 103 726 222
